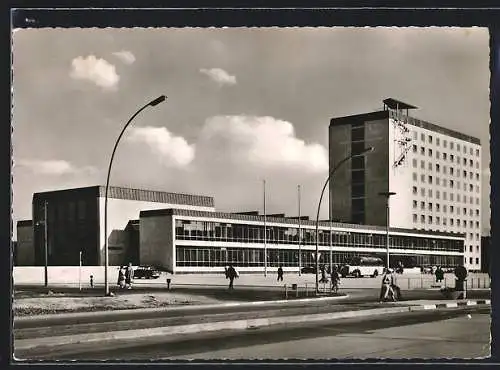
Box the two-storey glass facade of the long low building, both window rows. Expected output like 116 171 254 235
175 220 463 267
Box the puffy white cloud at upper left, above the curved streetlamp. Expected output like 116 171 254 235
70 55 120 89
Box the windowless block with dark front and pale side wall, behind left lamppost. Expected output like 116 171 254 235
33 186 214 266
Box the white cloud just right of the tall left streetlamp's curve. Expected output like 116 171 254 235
127 127 195 167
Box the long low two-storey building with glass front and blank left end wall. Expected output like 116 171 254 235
140 209 464 273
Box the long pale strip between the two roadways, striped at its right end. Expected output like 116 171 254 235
14 300 491 351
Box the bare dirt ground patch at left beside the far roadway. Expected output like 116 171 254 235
12 292 234 316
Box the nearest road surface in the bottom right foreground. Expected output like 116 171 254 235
46 307 490 360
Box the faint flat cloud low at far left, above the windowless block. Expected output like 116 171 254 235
14 159 96 176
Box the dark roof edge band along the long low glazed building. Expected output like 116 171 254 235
140 208 465 238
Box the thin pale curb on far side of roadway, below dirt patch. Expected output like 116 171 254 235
14 294 349 323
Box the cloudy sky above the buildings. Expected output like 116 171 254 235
12 27 490 238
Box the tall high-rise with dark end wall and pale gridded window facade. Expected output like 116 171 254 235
329 98 482 270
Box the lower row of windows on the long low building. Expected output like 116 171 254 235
176 246 462 268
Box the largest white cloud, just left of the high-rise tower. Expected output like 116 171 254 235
197 116 328 173
